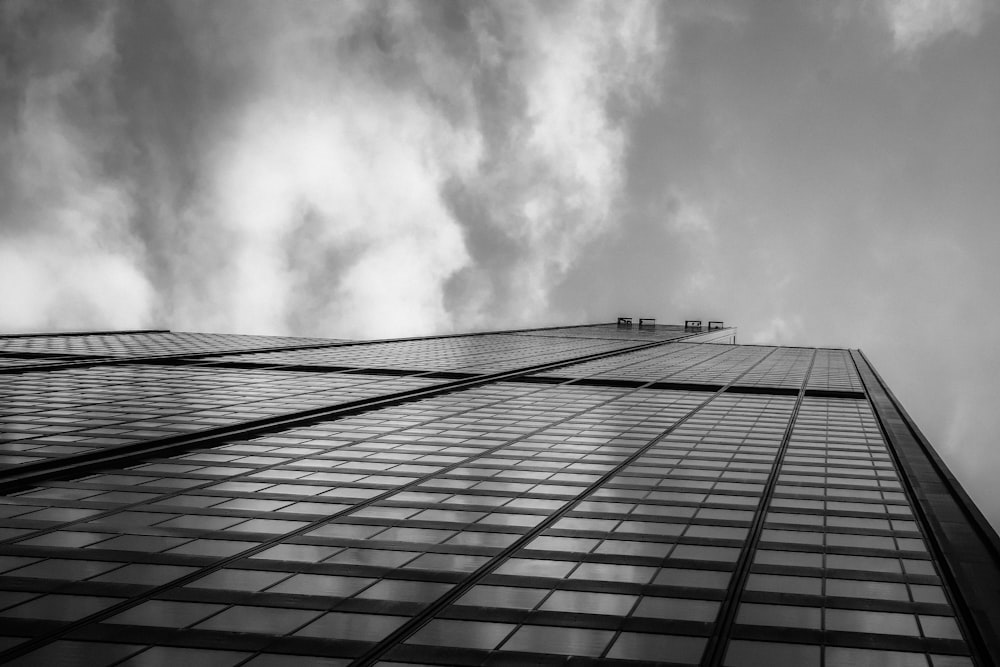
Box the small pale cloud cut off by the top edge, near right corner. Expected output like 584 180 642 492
883 0 987 53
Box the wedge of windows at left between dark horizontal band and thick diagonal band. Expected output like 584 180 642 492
0 364 442 466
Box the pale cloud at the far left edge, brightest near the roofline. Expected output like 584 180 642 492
0 4 153 330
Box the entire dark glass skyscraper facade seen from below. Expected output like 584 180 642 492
0 318 1000 667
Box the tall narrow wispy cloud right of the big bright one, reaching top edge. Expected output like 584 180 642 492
446 3 666 322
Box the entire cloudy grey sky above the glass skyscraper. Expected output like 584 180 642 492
0 0 1000 525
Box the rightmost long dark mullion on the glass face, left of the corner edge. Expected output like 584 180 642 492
700 348 816 667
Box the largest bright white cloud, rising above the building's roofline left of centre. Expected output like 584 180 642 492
168 9 479 336
